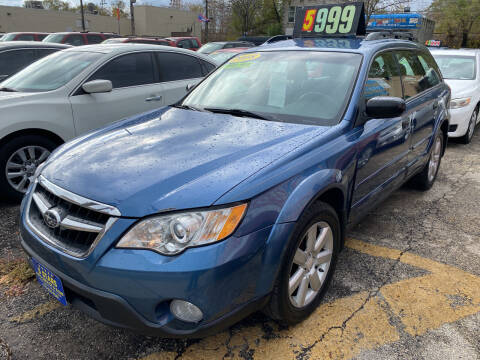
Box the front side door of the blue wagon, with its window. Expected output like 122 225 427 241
352 51 410 214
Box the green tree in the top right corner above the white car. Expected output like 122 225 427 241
429 0 480 47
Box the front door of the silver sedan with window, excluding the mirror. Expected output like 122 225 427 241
70 52 164 135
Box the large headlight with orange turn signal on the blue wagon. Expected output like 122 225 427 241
117 204 247 255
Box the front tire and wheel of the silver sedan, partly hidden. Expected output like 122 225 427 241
0 135 57 201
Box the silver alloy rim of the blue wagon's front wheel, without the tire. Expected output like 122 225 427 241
288 221 333 308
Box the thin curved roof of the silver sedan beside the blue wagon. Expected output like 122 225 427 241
65 43 216 62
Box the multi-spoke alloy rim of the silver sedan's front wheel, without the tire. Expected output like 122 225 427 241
5 145 50 193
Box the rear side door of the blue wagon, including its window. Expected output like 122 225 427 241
396 50 442 172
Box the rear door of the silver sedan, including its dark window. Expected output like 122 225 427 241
155 51 205 105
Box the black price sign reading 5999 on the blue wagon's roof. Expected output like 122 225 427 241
293 2 365 38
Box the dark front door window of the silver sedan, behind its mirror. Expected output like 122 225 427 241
88 52 156 89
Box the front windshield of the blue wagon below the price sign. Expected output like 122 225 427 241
182 51 362 126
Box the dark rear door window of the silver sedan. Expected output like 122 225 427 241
156 52 203 82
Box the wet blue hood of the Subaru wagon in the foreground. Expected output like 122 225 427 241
42 108 328 217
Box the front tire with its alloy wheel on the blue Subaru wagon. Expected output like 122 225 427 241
265 202 341 324
